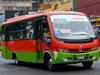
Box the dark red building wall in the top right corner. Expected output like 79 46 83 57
77 0 100 17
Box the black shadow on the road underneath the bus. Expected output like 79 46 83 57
5 63 93 72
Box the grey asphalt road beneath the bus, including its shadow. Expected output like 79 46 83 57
0 53 100 75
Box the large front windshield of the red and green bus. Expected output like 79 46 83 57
50 15 95 40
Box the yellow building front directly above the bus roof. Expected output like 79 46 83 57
41 0 76 12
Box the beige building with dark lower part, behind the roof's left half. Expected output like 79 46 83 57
0 0 40 20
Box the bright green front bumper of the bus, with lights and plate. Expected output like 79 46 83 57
52 50 99 64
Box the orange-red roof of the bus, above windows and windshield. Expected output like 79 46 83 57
3 11 85 25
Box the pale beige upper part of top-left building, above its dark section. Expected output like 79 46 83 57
0 0 39 12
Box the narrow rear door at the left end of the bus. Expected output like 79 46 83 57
5 26 10 58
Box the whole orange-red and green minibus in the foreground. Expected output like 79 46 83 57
2 11 99 70
